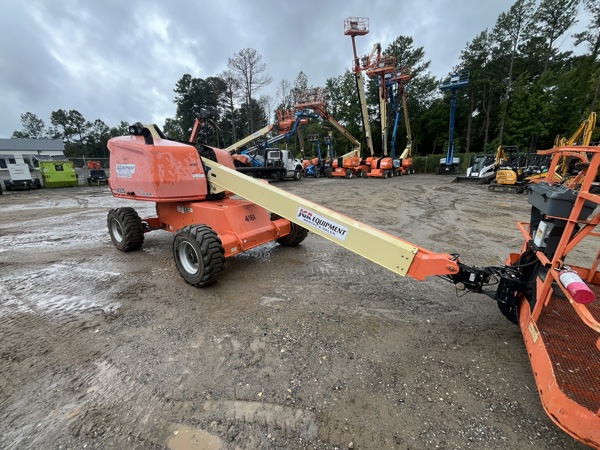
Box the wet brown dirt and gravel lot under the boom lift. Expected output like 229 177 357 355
0 174 583 450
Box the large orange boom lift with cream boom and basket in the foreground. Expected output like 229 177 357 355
107 123 600 448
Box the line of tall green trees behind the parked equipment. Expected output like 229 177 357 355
13 0 600 157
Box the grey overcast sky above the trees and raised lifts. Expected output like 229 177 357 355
0 0 584 138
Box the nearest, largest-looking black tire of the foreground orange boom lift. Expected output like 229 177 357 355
173 225 225 287
